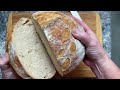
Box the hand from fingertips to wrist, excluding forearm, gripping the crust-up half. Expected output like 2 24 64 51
72 17 107 67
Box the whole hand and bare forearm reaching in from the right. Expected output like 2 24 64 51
72 17 120 79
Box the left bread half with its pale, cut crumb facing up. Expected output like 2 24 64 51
8 18 56 79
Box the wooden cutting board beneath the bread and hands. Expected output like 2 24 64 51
7 12 102 78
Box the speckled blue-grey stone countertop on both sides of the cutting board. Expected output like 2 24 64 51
0 11 111 77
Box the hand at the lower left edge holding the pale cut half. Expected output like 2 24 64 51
0 53 20 79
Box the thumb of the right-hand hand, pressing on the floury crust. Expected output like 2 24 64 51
72 30 90 46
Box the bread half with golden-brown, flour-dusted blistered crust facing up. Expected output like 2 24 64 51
32 11 85 76
